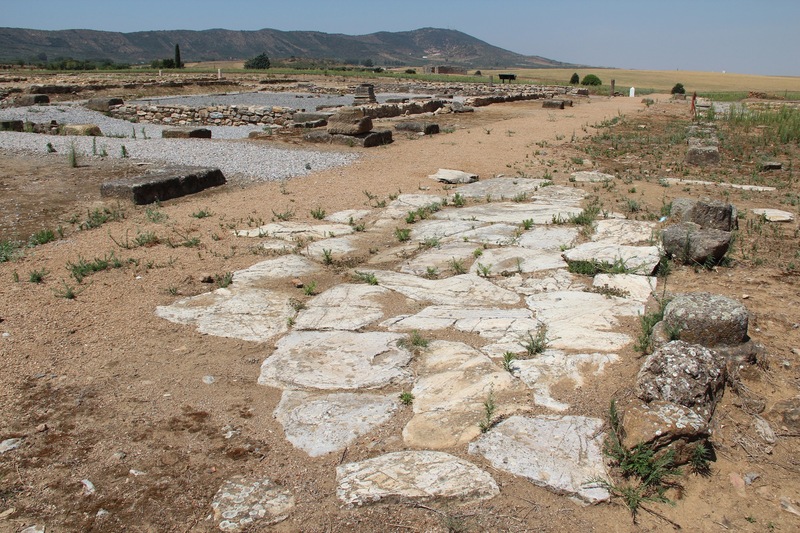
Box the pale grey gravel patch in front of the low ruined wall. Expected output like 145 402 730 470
0 105 358 182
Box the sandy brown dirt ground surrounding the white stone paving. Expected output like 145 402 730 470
0 71 800 532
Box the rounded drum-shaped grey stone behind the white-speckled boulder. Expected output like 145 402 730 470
663 292 749 347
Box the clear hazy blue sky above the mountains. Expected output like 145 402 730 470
0 0 800 76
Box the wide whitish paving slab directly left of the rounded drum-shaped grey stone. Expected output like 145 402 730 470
526 291 644 352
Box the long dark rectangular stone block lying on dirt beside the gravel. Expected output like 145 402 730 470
100 167 225 205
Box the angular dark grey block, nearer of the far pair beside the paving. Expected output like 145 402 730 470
661 222 731 265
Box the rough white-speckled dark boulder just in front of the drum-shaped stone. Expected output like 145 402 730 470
636 341 727 421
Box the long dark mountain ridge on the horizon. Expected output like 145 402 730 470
0 28 573 68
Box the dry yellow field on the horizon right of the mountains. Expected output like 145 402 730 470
482 68 800 94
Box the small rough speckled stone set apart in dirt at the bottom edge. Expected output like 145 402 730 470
211 476 295 531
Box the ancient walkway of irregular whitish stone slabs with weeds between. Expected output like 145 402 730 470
156 175 660 529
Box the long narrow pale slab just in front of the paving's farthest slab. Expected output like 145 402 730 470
433 202 583 224
